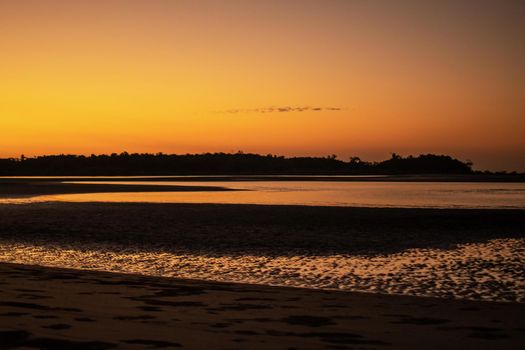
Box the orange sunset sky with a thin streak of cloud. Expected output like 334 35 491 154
0 0 525 171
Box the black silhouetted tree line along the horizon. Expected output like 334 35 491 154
0 152 473 176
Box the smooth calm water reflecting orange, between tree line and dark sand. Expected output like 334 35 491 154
10 181 525 208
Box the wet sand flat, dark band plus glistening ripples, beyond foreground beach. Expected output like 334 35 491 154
0 202 525 302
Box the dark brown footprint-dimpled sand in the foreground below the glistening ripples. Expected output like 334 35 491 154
0 263 525 350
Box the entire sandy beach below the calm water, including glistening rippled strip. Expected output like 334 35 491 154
0 184 525 349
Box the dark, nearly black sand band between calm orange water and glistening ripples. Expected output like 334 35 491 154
0 202 525 256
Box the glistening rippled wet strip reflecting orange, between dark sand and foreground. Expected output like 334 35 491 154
0 239 525 302
